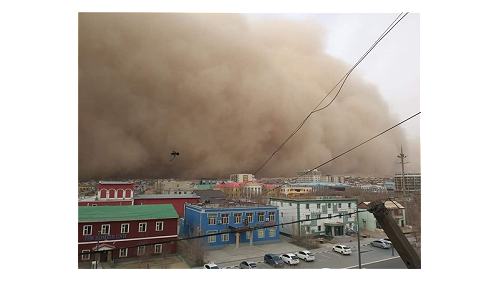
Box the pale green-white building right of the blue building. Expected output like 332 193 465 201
270 196 358 238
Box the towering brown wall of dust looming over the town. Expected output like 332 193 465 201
78 13 420 179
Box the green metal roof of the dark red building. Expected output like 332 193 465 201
78 204 178 222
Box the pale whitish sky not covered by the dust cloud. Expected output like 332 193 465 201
244 12 421 138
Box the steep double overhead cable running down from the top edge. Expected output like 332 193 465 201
253 12 409 175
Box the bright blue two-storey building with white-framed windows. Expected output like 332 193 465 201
179 204 279 249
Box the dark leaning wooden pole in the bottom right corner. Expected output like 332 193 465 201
368 200 421 269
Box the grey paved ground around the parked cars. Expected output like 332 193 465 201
218 245 407 269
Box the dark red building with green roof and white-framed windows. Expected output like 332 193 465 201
78 204 178 262
